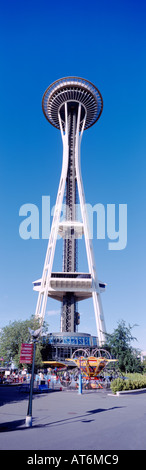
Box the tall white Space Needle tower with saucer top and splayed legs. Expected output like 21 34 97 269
34 77 106 352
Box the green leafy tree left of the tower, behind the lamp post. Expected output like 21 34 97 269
0 315 47 367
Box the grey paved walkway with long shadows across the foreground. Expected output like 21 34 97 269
0 387 146 450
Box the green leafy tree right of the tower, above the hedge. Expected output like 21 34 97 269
104 320 142 372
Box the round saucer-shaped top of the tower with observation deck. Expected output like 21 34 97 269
42 77 103 129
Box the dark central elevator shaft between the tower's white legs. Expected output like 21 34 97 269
62 104 77 332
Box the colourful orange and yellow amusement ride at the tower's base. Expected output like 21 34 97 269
44 348 117 388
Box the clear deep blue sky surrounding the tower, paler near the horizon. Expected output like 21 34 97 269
0 0 146 349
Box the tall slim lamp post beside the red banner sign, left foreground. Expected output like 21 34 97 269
25 328 41 427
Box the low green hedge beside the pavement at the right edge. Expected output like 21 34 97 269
111 374 146 393
